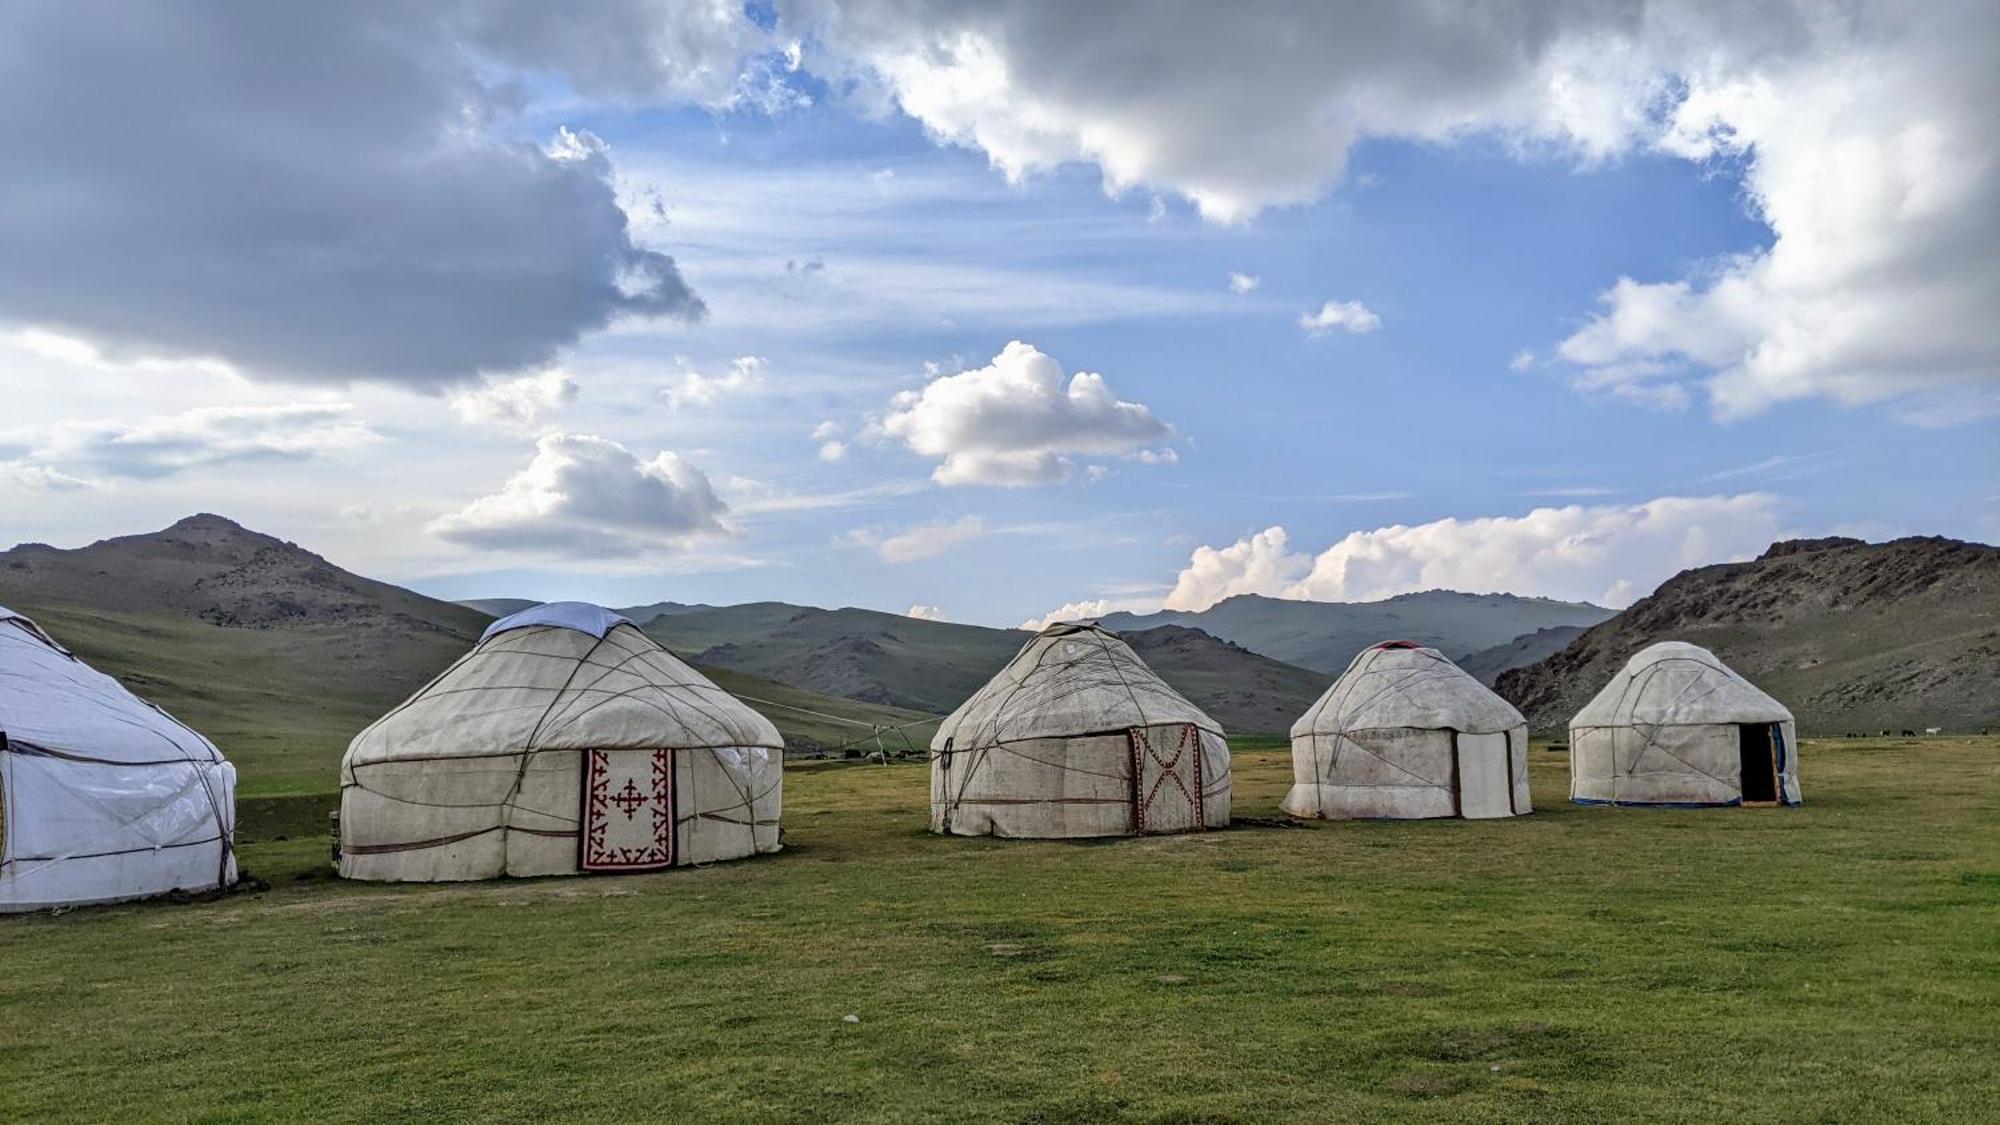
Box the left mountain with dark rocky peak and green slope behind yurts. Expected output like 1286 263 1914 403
0 514 936 793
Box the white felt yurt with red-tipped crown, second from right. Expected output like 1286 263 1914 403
1284 641 1530 819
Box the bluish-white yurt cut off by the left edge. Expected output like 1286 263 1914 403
0 607 236 911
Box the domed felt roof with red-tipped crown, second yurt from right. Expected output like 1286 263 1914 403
1292 641 1526 739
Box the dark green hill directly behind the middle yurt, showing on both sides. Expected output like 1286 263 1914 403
646 603 1326 733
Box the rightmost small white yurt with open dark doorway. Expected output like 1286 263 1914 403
1570 641 1800 805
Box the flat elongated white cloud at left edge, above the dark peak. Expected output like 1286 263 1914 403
14 402 382 486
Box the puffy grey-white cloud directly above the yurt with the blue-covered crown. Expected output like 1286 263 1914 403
430 434 730 558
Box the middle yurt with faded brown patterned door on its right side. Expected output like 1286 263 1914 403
930 623 1230 839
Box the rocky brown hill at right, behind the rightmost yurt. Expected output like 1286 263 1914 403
1496 538 2000 735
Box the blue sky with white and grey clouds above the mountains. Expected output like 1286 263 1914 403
0 0 2000 627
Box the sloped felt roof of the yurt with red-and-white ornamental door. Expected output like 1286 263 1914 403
346 607 784 767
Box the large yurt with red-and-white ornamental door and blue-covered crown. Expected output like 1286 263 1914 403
338 603 784 881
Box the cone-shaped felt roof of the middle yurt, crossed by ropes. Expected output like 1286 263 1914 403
932 621 1222 749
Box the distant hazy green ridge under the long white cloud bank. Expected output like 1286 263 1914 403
1098 591 1612 675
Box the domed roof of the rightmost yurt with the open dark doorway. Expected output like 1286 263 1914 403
1570 641 1792 727
